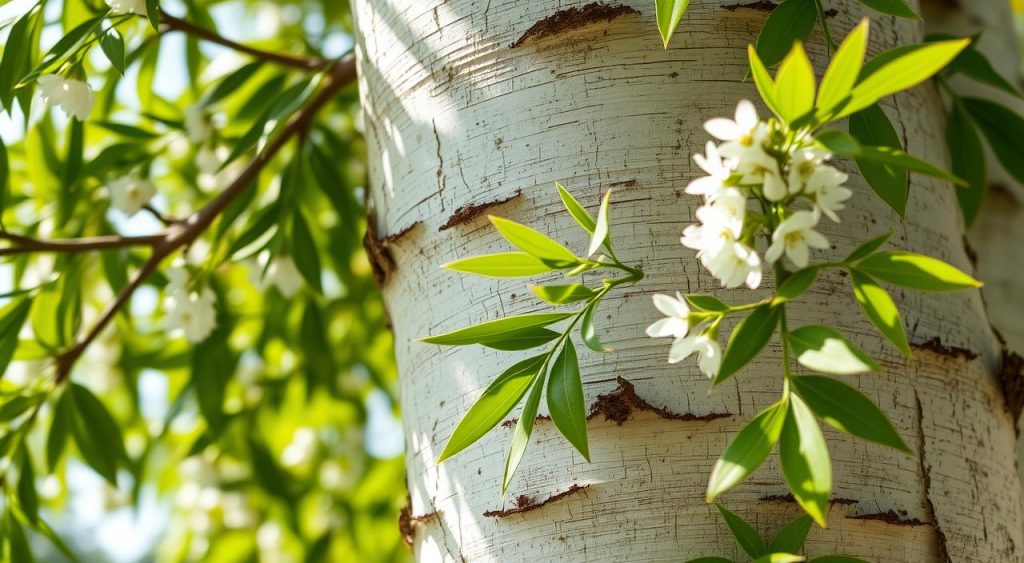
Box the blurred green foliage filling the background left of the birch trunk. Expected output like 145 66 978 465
0 0 409 562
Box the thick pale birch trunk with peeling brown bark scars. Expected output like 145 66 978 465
354 0 1024 562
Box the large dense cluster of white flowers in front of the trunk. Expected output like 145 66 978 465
682 100 852 289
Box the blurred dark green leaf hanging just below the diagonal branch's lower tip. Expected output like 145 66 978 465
70 383 126 487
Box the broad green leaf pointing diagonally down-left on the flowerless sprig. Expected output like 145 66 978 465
437 354 545 464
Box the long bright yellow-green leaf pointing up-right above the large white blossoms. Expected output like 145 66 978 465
836 39 970 119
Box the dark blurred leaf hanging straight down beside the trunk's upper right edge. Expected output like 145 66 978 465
946 101 987 226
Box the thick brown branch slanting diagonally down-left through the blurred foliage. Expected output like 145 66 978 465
55 55 355 384
